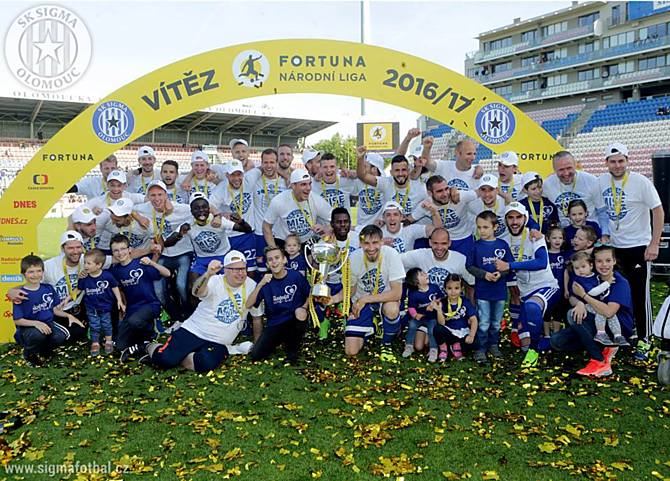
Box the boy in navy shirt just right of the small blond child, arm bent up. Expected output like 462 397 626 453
109 234 170 362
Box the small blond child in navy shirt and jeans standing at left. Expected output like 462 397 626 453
77 249 126 356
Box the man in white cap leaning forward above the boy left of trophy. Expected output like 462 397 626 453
263 169 332 247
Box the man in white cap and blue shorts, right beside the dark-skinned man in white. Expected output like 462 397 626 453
210 159 256 272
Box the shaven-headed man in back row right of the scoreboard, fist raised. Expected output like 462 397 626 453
424 137 484 190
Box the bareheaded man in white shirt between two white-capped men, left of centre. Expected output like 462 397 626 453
244 149 286 272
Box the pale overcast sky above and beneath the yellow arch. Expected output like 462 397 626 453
0 1 570 143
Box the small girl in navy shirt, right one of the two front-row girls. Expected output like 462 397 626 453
402 267 442 362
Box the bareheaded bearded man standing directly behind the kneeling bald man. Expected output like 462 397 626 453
407 175 477 256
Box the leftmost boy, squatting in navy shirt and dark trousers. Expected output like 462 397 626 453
13 254 83 366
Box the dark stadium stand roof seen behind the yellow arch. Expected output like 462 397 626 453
0 97 337 137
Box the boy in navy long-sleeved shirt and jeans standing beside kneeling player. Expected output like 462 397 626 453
467 210 514 363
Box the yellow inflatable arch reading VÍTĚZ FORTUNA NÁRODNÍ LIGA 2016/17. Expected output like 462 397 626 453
0 39 560 342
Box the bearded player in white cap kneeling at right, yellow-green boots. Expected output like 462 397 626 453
495 202 561 368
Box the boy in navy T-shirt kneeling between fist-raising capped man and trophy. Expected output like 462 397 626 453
246 246 310 364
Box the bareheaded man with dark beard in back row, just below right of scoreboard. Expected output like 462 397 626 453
356 146 426 216
